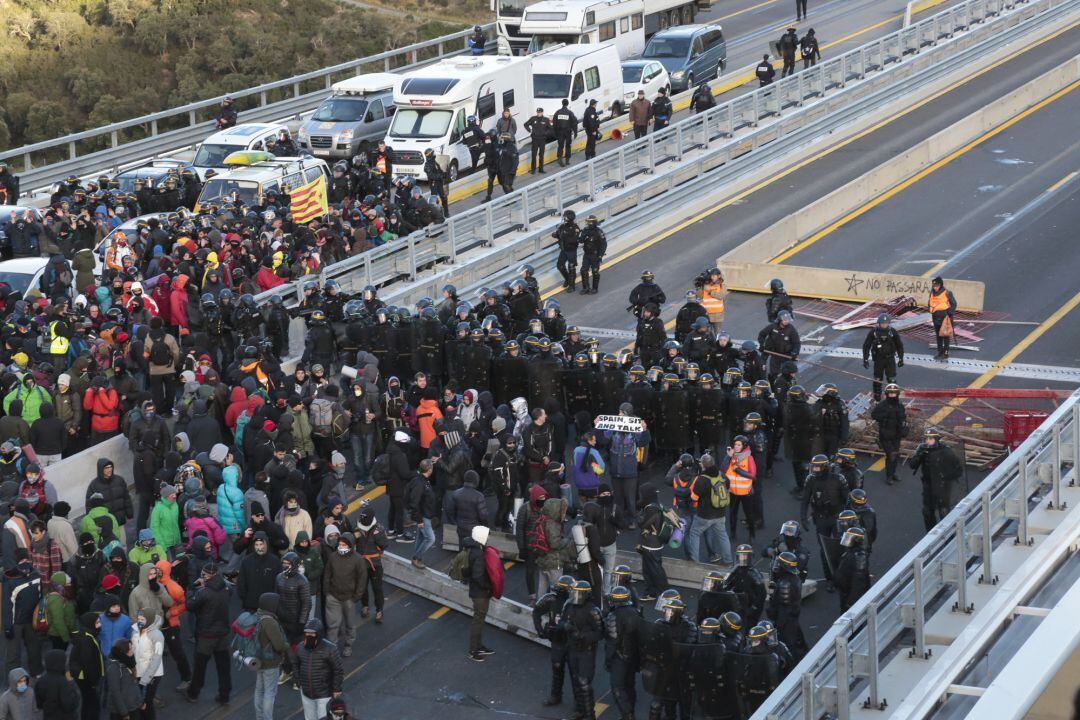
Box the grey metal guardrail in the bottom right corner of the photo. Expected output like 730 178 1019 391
752 391 1080 720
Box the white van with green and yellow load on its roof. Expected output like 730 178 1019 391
194 154 330 213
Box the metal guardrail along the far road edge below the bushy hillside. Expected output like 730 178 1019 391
0 23 495 190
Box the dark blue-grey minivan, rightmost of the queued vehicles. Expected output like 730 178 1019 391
642 25 728 93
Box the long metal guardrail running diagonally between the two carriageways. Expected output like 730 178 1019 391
252 0 1080 310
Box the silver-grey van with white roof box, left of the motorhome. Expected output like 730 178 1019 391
296 72 401 158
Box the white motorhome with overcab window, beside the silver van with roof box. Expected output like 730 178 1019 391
386 55 534 180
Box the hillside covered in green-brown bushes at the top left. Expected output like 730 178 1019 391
0 0 489 148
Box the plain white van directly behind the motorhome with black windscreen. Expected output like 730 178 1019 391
532 42 623 120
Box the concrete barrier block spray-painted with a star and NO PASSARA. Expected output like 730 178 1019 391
717 258 986 312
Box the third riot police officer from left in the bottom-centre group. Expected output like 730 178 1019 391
604 587 642 720
